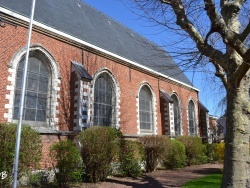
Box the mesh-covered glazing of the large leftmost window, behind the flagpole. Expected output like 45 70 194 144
13 57 50 122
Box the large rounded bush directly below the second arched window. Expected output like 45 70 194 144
78 126 120 182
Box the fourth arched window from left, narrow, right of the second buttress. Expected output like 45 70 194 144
171 95 181 136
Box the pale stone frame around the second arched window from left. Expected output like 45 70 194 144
90 67 121 129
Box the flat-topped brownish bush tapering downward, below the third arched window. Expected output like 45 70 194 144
139 135 170 172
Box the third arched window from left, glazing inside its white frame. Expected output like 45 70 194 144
139 86 153 132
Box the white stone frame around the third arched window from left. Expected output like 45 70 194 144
136 82 157 135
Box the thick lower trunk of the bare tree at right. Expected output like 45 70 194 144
221 76 250 188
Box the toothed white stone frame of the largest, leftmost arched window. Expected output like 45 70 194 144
4 44 61 132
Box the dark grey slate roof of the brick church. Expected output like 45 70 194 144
0 0 193 87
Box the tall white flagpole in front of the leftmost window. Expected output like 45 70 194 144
13 0 36 188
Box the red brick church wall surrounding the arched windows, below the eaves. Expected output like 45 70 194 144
0 21 198 134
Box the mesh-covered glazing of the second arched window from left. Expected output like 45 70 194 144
94 73 116 126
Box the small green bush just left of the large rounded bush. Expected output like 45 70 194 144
50 140 83 187
